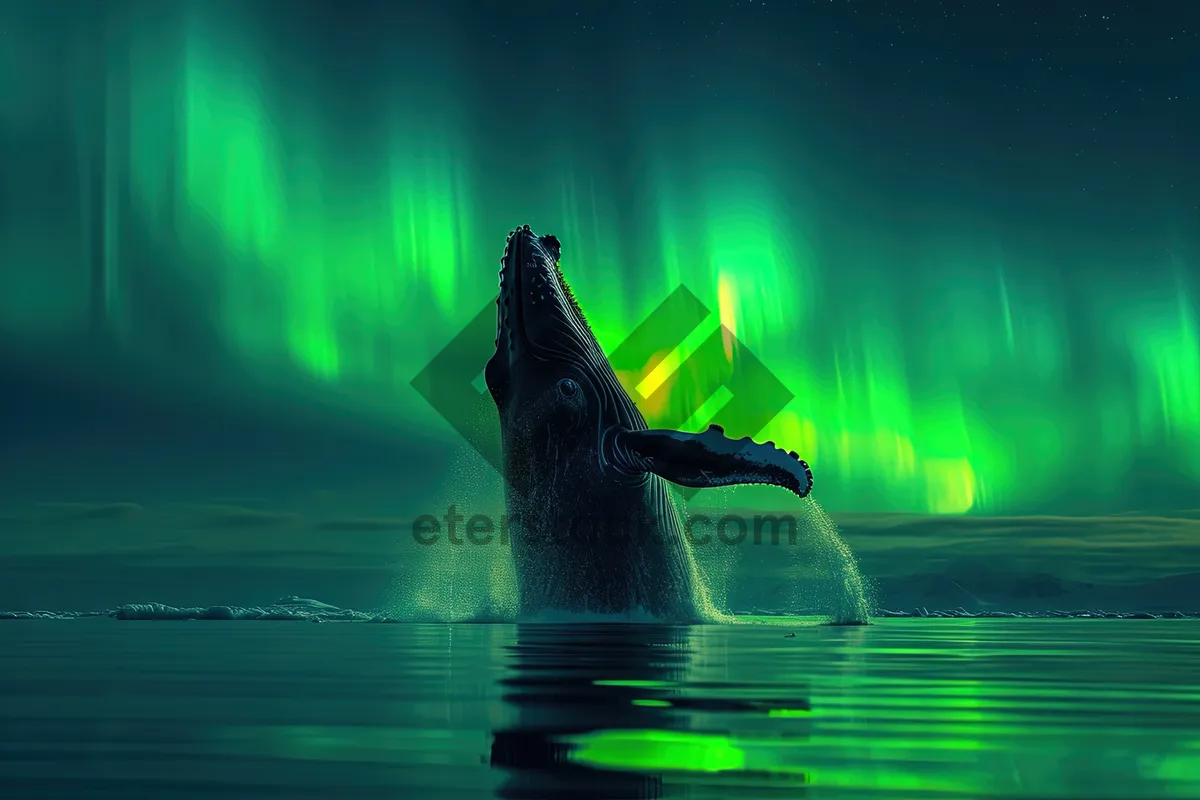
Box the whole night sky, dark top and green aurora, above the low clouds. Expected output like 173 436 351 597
0 1 1200 515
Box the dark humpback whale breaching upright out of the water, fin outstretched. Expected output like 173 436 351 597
484 225 812 621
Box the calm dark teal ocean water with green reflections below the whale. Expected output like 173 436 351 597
0 618 1200 800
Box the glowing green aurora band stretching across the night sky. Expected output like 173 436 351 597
0 2 1200 515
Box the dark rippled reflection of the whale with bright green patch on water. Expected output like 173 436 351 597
491 625 809 800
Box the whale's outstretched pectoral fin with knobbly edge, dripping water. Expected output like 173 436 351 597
619 425 812 498
